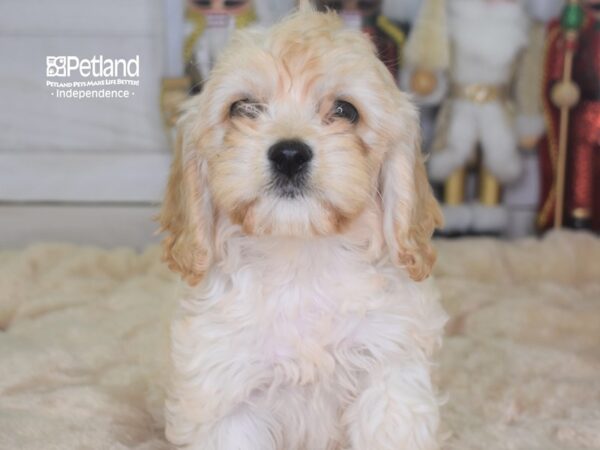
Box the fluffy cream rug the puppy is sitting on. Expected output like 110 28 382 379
0 232 600 450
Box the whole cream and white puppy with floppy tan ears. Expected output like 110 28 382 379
160 6 446 450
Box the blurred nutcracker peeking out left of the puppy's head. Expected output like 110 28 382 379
183 0 256 91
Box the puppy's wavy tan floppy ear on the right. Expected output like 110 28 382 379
380 94 443 281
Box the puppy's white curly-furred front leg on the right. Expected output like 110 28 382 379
344 362 439 450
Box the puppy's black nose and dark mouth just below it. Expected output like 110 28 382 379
268 139 313 197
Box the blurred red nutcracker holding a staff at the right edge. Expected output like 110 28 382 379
538 0 600 231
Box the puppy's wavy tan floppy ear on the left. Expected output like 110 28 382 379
158 117 214 286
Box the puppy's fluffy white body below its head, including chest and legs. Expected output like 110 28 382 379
167 237 445 450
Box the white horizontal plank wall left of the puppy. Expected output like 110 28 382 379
0 0 179 249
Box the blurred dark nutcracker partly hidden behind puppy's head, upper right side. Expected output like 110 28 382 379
316 0 405 78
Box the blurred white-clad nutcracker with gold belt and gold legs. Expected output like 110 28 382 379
407 0 528 234
